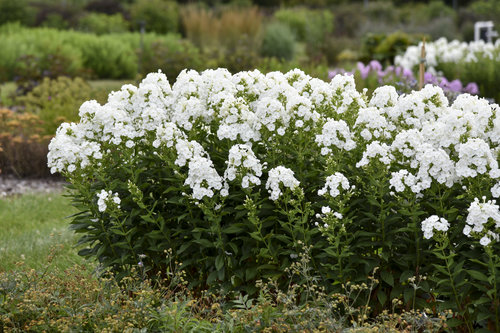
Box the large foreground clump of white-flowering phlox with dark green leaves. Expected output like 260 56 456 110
48 69 500 330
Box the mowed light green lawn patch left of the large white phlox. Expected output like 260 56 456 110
0 193 83 272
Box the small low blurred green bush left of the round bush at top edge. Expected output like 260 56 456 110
78 13 128 35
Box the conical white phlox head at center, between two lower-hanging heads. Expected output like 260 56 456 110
224 144 262 188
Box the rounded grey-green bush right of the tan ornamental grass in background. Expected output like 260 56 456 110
260 22 295 60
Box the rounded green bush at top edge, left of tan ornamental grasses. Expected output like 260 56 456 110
130 0 179 34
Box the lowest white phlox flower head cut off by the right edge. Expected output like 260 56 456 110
463 197 500 246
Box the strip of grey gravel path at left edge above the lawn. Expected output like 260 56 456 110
0 176 66 197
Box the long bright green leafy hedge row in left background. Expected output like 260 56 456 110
0 25 201 80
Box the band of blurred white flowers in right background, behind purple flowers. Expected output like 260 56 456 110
394 38 500 74
